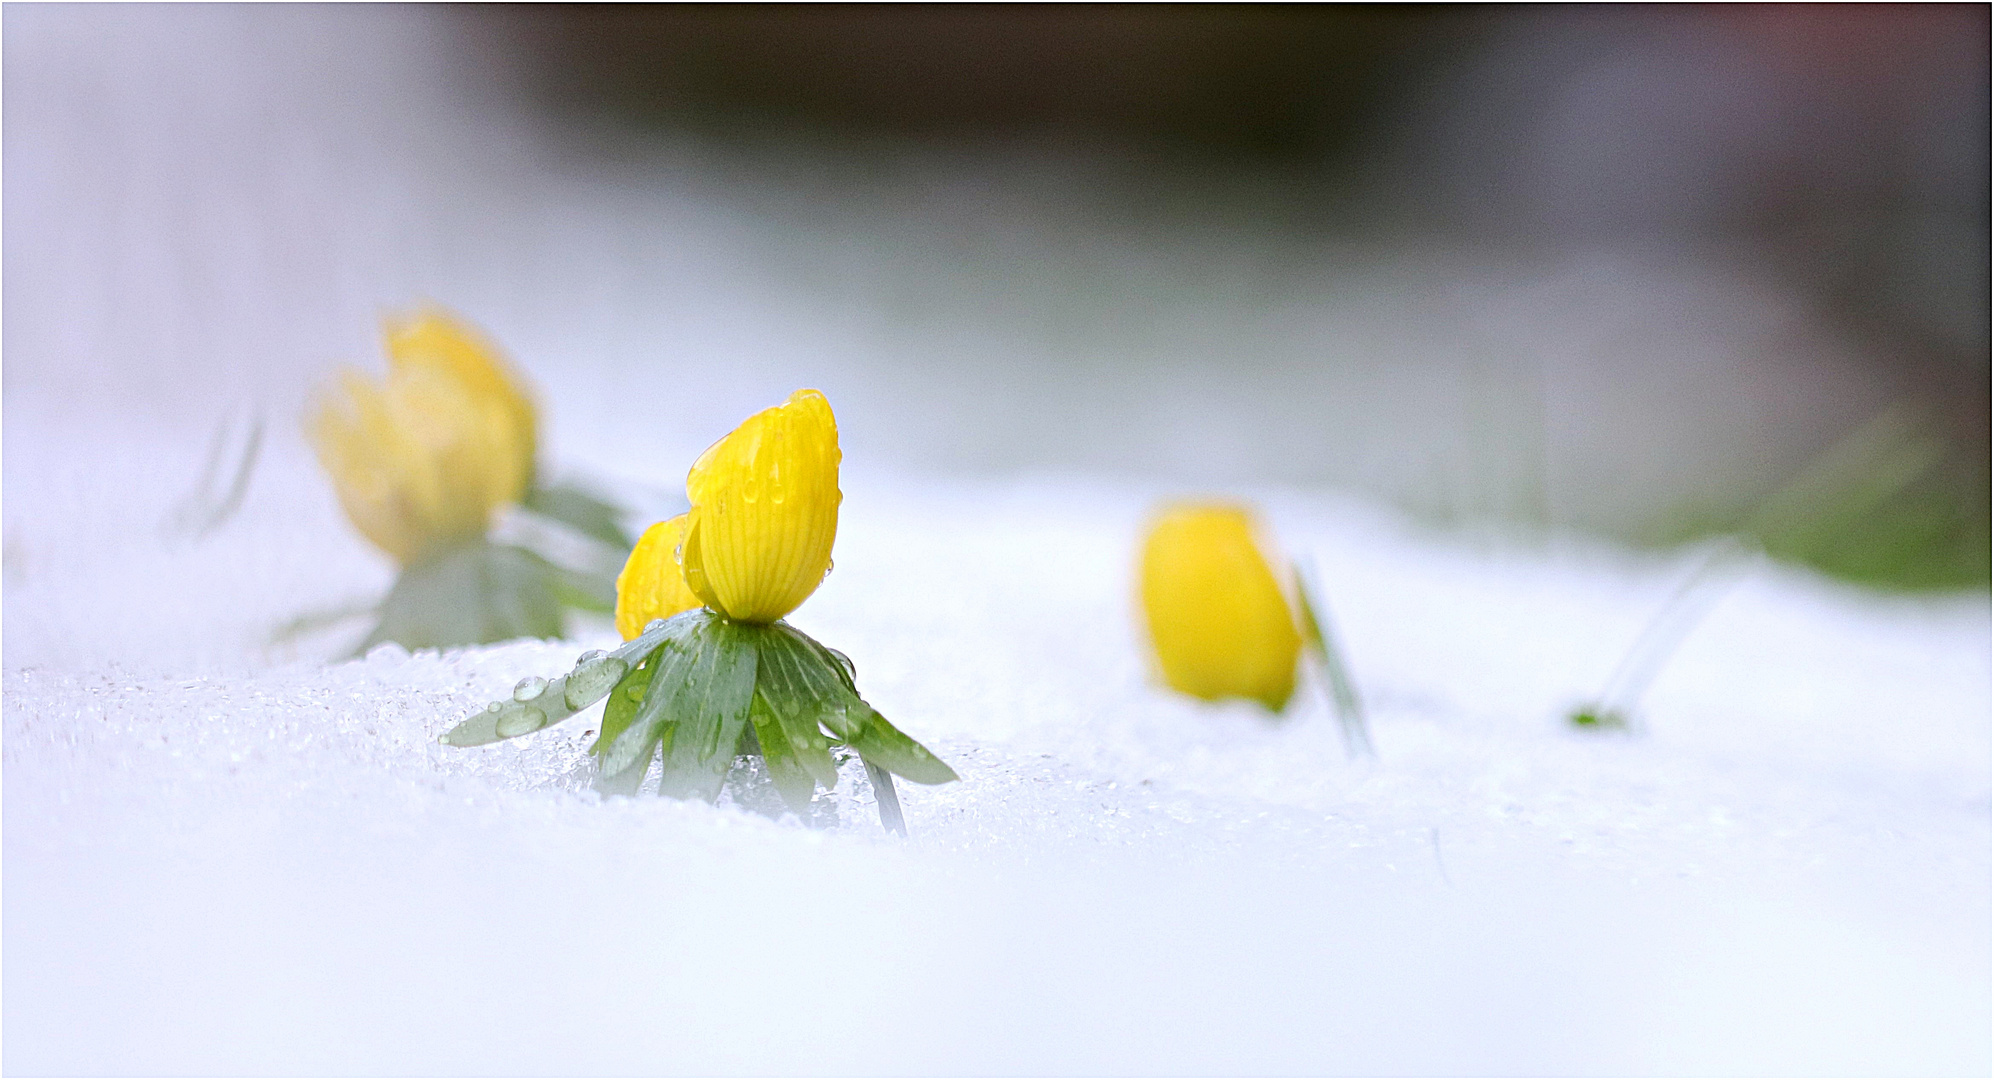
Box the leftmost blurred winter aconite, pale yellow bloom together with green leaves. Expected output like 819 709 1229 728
299 307 630 652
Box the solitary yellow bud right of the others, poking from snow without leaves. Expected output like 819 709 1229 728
1143 504 1302 711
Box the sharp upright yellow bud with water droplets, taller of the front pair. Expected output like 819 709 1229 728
680 391 843 624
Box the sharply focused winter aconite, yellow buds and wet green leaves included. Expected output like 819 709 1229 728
454 391 955 833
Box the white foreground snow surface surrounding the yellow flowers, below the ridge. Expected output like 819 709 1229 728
4 406 1990 1074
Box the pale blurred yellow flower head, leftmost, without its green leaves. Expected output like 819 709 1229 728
305 315 532 566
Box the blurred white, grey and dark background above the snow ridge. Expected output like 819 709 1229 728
0 4 1990 590
